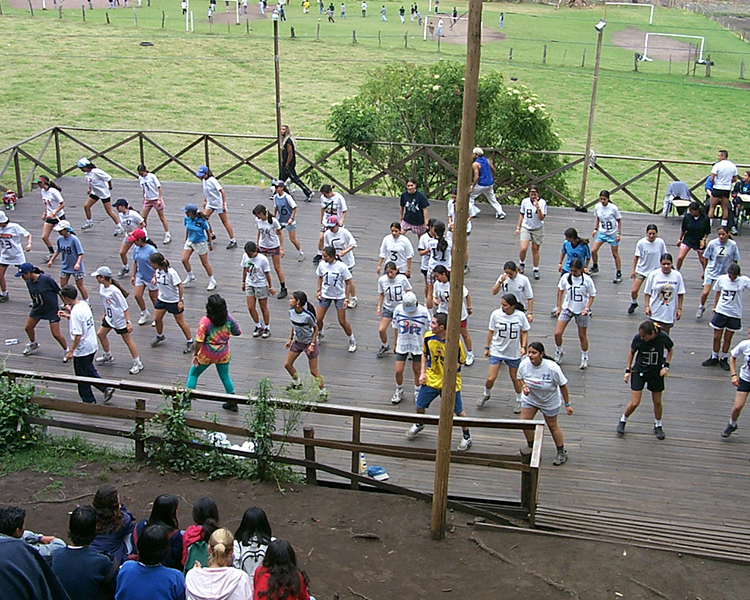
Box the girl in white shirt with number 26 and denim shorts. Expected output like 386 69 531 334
477 294 531 414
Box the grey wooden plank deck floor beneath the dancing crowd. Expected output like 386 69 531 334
0 178 750 524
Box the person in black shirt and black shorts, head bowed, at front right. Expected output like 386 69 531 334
617 321 674 440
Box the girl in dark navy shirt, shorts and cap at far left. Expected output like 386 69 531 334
16 263 68 356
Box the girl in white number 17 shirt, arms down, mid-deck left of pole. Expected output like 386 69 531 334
315 246 357 352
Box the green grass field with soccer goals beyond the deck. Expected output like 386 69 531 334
0 0 750 206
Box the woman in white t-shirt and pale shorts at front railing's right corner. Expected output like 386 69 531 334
517 342 573 467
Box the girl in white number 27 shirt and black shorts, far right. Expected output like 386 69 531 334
701 263 750 371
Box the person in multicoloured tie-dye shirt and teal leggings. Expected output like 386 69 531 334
185 294 242 412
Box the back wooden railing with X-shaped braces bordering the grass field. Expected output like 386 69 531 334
0 126 747 213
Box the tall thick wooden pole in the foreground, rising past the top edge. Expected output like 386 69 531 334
430 0 482 540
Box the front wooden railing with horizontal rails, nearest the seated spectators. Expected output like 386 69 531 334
0 369 544 525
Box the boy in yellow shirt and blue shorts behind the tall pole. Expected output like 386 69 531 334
406 313 471 452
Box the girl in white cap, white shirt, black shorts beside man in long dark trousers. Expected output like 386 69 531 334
91 267 143 375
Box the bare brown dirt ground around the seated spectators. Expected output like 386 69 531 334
0 464 747 600
